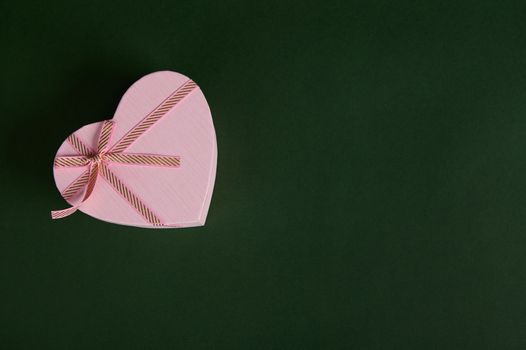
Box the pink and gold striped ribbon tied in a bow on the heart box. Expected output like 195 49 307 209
51 80 197 226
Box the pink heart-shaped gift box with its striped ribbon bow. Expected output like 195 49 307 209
52 71 217 228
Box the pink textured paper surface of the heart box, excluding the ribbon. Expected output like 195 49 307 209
54 71 217 228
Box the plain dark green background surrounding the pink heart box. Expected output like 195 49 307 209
0 0 526 349
